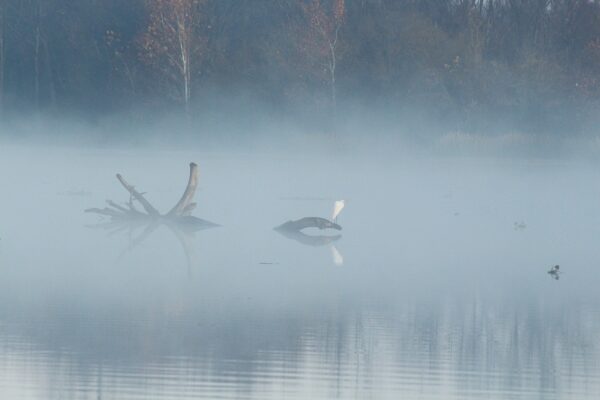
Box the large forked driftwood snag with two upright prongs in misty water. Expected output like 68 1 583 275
85 163 218 232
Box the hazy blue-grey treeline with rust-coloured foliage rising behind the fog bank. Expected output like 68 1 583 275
0 0 600 131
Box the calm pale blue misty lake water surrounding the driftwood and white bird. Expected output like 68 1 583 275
0 147 600 400
